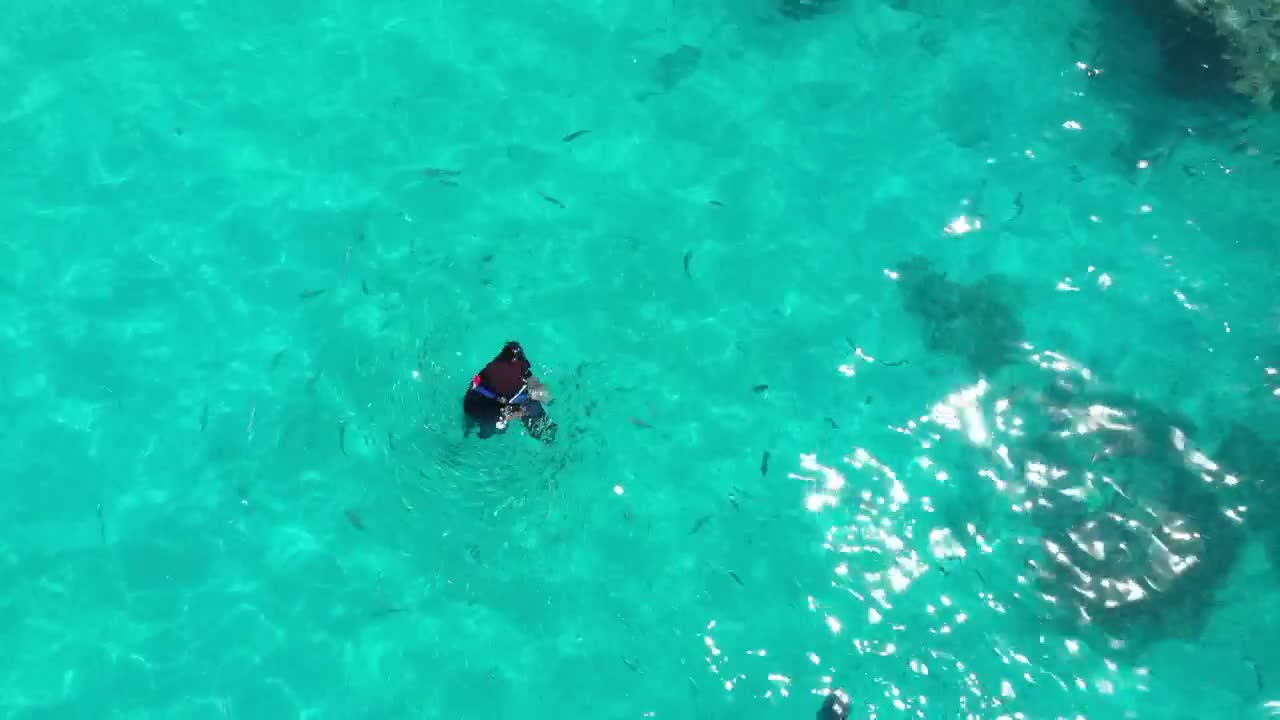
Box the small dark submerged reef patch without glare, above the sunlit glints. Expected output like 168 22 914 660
899 256 1023 375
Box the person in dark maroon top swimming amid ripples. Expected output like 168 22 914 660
462 341 557 442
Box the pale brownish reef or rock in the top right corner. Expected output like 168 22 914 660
1174 0 1280 106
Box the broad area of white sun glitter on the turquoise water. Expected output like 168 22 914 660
703 345 1249 717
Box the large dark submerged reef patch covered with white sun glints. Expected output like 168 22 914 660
1027 384 1252 652
